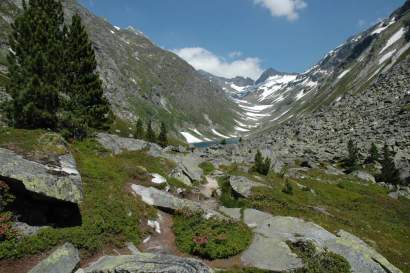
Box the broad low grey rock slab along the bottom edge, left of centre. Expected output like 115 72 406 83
84 253 214 273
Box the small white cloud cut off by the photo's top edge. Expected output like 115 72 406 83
254 0 307 21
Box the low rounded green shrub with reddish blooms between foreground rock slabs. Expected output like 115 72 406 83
173 210 252 260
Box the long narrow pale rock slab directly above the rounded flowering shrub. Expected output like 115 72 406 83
131 185 224 219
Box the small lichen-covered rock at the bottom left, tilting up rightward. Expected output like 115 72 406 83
29 243 80 273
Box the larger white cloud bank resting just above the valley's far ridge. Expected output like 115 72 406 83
173 47 263 79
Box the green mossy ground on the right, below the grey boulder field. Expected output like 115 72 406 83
220 163 410 272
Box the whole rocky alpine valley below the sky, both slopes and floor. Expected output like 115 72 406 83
0 0 410 273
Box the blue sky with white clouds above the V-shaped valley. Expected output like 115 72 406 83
80 0 405 78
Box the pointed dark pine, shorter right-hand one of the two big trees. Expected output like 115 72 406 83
62 14 111 138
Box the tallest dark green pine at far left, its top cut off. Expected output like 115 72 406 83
7 0 64 129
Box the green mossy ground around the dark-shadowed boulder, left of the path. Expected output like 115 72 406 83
0 130 172 259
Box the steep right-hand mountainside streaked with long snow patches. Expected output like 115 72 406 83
219 1 410 134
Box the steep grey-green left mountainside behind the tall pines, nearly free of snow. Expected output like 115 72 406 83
0 0 235 138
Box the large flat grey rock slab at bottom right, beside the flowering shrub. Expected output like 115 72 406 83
241 209 401 273
